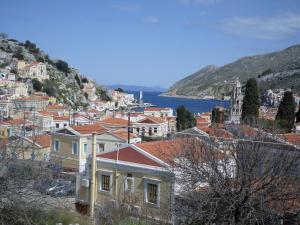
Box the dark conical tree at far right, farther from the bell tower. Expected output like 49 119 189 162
275 91 296 132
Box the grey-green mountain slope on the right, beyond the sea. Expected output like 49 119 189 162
164 45 300 98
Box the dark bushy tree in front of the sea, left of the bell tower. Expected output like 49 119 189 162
176 105 196 131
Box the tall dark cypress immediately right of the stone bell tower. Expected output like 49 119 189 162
242 78 260 124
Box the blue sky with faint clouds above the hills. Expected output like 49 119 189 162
0 0 300 88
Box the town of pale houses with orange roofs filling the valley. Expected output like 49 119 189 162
0 55 300 224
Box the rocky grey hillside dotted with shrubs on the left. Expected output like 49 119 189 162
0 38 109 108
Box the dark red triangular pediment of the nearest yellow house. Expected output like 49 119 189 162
97 146 162 167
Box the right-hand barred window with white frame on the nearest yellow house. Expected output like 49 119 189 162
144 179 160 207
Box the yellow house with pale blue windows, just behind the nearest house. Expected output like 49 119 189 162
51 124 106 172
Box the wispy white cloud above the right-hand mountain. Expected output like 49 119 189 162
219 14 300 40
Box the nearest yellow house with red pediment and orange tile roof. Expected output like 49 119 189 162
76 140 180 224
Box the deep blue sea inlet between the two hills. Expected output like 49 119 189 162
128 92 229 113
